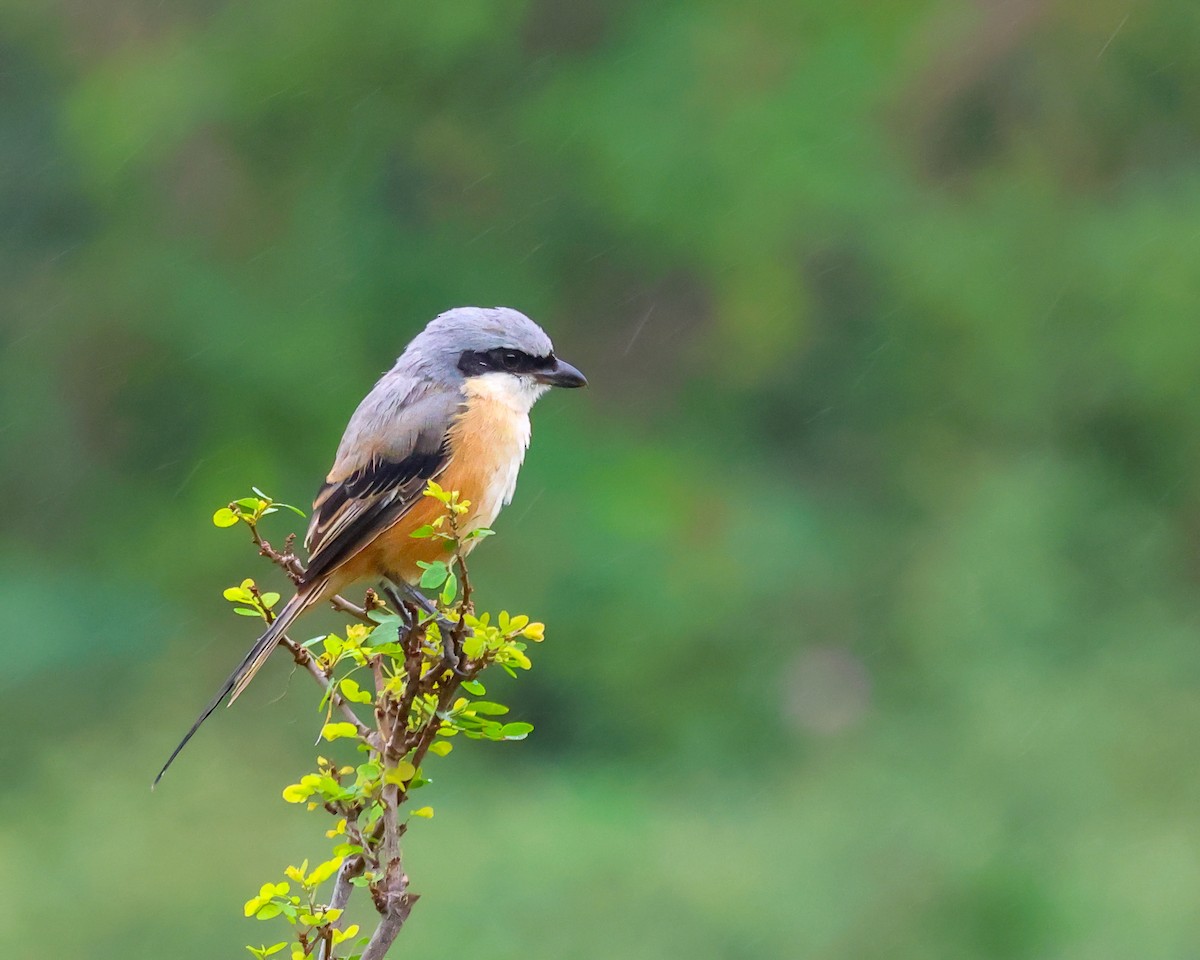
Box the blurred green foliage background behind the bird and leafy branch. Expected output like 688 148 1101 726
0 0 1200 960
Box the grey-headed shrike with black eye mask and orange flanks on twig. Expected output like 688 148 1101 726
154 307 587 785
